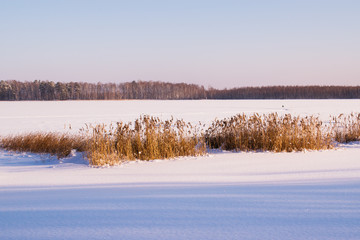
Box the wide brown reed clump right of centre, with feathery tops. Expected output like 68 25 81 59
205 113 332 152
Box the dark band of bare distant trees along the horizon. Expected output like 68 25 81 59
0 80 360 101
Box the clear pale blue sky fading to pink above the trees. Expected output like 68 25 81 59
0 0 360 88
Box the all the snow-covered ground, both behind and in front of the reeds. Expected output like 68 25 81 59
0 100 360 239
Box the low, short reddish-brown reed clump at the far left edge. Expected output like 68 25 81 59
0 132 87 158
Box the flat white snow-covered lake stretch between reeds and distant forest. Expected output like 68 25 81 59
0 99 360 135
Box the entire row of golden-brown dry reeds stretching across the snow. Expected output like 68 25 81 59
0 113 360 166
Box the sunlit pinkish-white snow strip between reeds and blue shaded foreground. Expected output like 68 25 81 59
0 143 360 188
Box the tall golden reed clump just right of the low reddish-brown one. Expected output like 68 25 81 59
85 116 206 166
